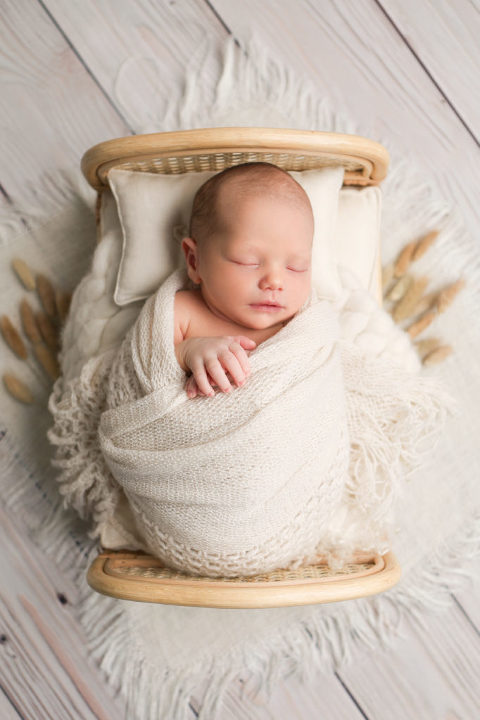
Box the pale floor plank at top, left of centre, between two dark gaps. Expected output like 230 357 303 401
43 0 227 132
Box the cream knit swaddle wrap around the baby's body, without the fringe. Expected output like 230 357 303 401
99 272 349 575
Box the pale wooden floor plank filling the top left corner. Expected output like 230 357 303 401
0 0 130 201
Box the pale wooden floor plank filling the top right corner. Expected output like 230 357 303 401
381 0 480 141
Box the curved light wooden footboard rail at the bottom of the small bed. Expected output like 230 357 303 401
87 551 401 609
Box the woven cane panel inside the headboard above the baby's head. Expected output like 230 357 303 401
100 152 365 175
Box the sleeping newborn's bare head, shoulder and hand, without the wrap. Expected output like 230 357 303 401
174 162 313 398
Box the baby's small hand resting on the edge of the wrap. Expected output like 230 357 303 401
183 335 257 398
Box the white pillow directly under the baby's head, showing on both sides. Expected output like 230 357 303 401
108 167 344 306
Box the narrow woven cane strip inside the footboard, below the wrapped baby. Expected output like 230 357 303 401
108 560 375 584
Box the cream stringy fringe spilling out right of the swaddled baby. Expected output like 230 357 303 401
320 344 459 569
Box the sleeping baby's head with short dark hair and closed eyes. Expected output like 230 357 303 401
182 163 313 329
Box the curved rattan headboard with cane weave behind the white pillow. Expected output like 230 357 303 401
82 127 389 191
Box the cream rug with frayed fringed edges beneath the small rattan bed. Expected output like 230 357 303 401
0 35 480 720
